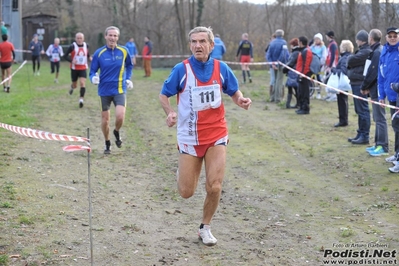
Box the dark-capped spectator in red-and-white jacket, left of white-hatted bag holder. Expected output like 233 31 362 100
322 31 339 101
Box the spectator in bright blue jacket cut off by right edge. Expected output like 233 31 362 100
377 27 399 173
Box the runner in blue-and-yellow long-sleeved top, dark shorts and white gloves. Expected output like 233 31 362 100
90 26 133 154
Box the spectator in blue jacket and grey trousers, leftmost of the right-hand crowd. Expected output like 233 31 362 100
266 29 289 103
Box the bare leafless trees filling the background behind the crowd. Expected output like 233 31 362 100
22 0 399 61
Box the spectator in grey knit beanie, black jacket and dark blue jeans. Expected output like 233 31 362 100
347 30 371 144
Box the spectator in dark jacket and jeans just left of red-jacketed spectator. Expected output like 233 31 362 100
283 38 303 109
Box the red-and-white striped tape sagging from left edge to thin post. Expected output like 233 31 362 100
0 123 90 146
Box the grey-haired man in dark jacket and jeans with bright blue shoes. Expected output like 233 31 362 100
360 29 388 156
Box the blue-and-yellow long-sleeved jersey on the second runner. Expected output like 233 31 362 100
90 45 133 96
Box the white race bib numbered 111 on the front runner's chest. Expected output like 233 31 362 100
191 84 222 111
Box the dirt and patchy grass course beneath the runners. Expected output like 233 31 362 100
0 71 399 266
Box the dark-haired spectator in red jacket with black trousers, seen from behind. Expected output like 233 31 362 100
296 36 313 115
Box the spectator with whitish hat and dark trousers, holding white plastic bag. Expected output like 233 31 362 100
331 40 354 127
